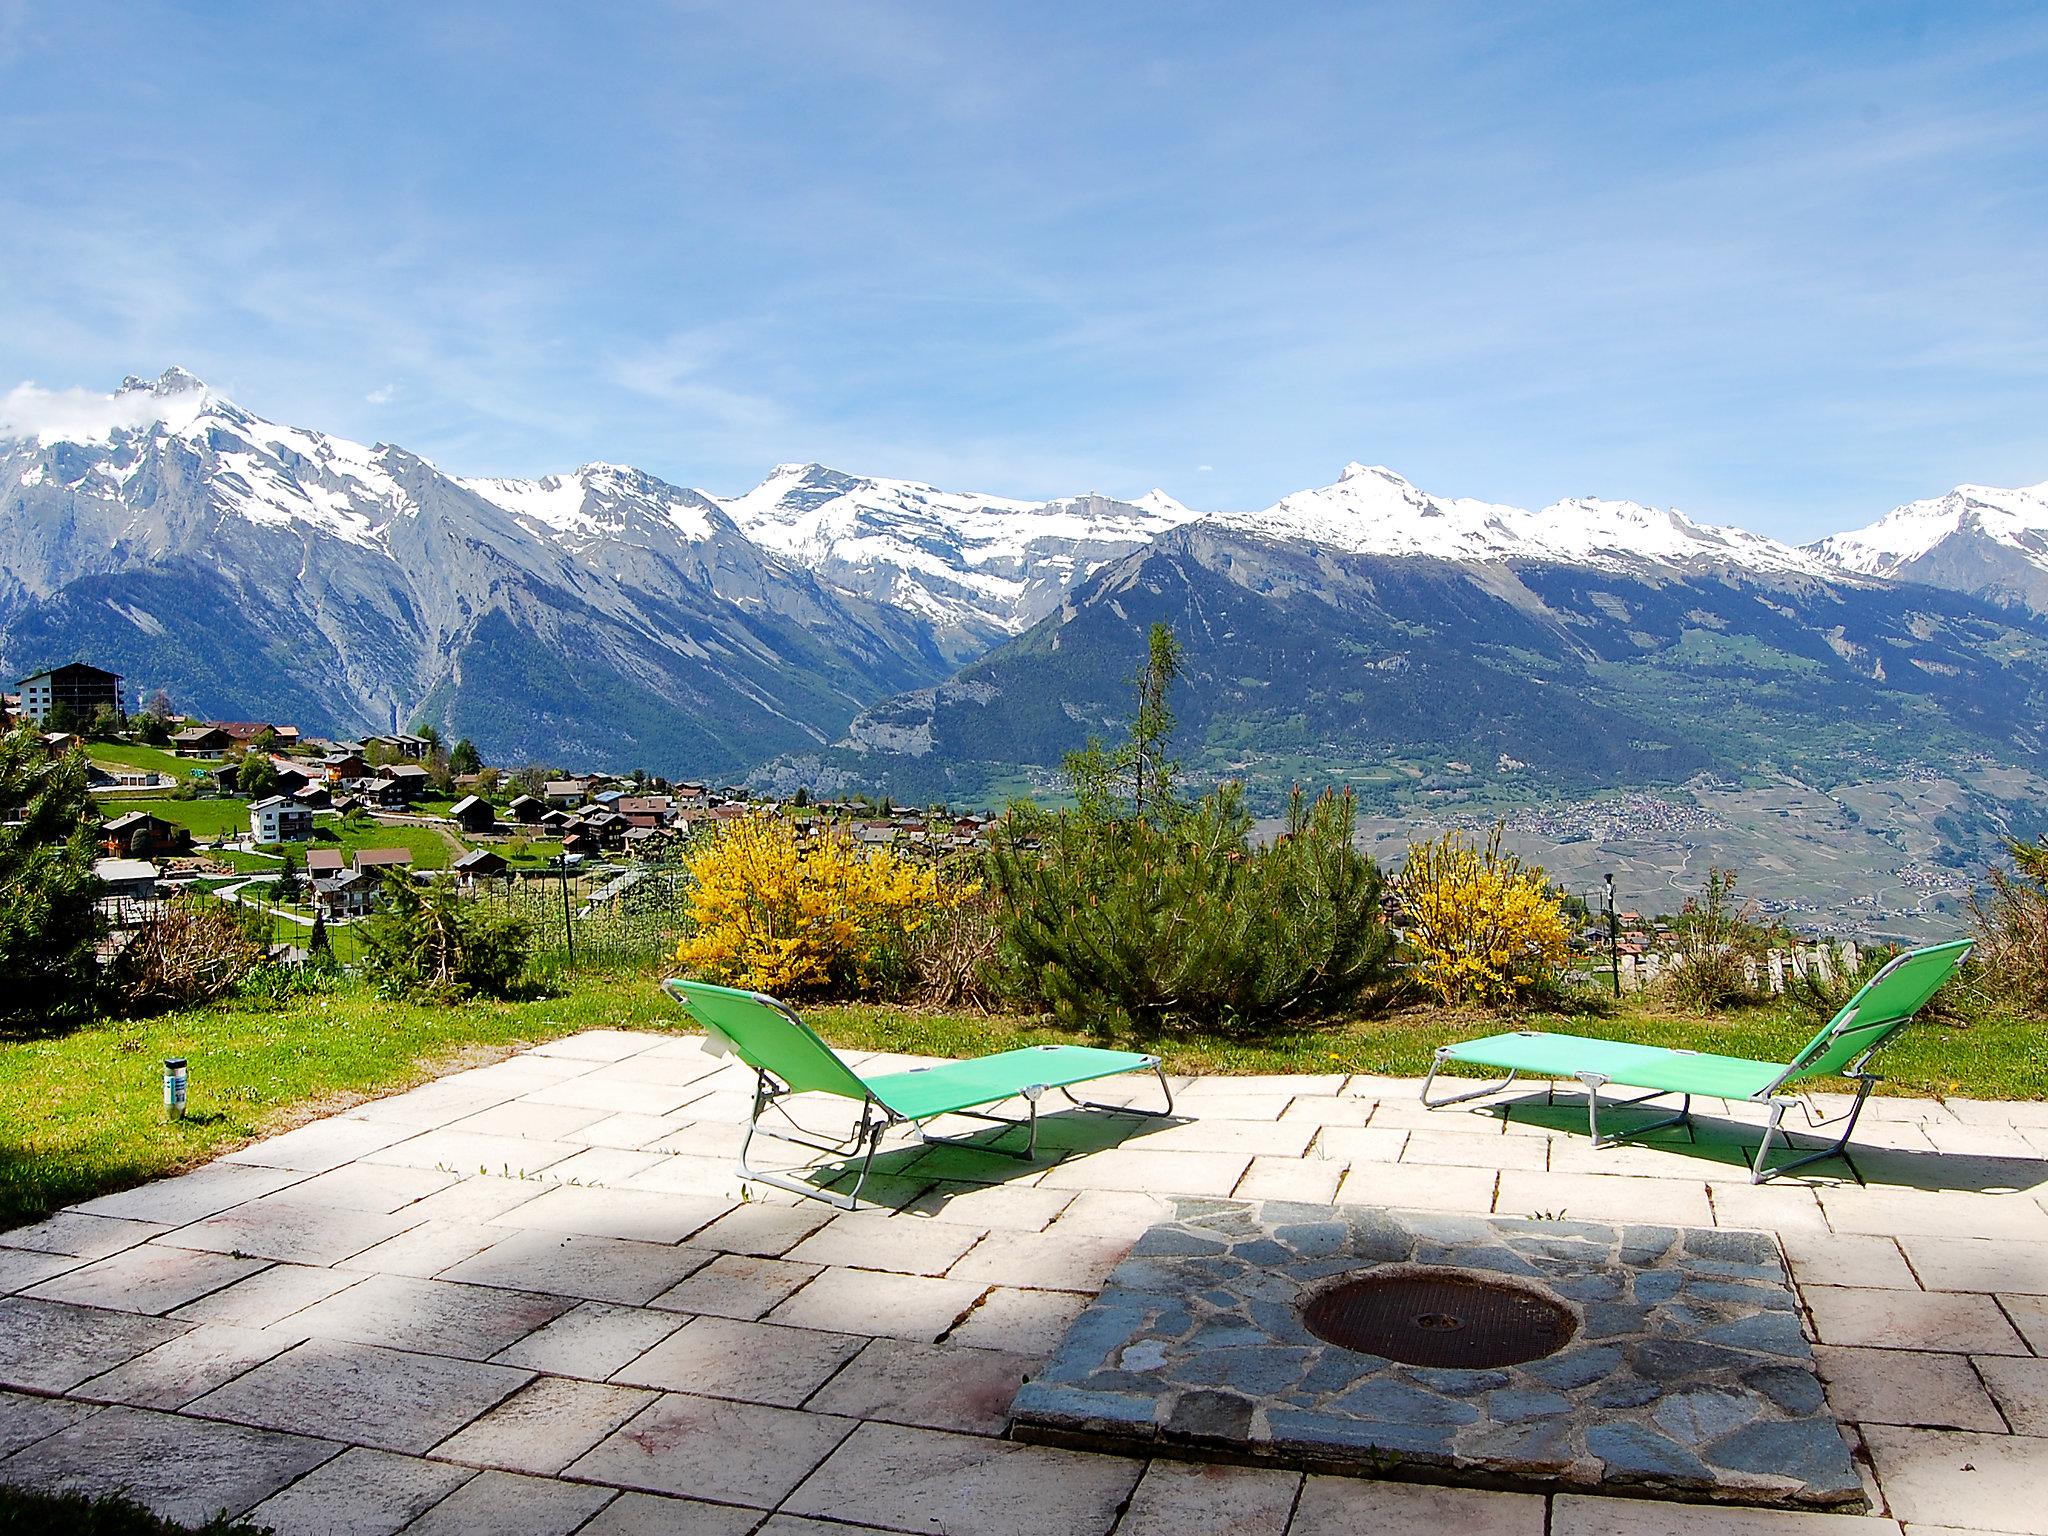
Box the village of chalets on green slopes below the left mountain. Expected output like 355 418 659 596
0 662 993 961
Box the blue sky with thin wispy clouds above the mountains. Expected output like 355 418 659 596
0 0 2048 539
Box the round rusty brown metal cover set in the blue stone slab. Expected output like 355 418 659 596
1303 1270 1577 1368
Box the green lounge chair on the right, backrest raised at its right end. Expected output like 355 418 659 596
1421 940 1970 1184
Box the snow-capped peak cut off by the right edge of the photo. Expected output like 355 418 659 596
1808 483 2048 612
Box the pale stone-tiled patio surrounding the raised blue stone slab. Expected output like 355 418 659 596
0 1030 2048 1536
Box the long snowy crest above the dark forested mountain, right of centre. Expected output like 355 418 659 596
1210 463 1827 575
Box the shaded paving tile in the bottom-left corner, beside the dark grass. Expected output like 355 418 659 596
6 1407 340 1526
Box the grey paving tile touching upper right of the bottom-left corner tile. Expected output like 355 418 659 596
186 1339 530 1452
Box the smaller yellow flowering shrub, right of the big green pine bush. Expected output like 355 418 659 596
1395 827 1571 1008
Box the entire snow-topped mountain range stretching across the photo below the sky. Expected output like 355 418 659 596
0 369 2048 819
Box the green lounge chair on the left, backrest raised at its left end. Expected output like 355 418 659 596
662 981 1174 1210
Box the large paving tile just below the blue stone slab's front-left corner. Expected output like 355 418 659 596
782 1423 1143 1536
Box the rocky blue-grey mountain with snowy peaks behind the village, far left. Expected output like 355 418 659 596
0 371 944 776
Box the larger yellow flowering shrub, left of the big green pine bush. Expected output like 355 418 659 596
676 815 942 995
